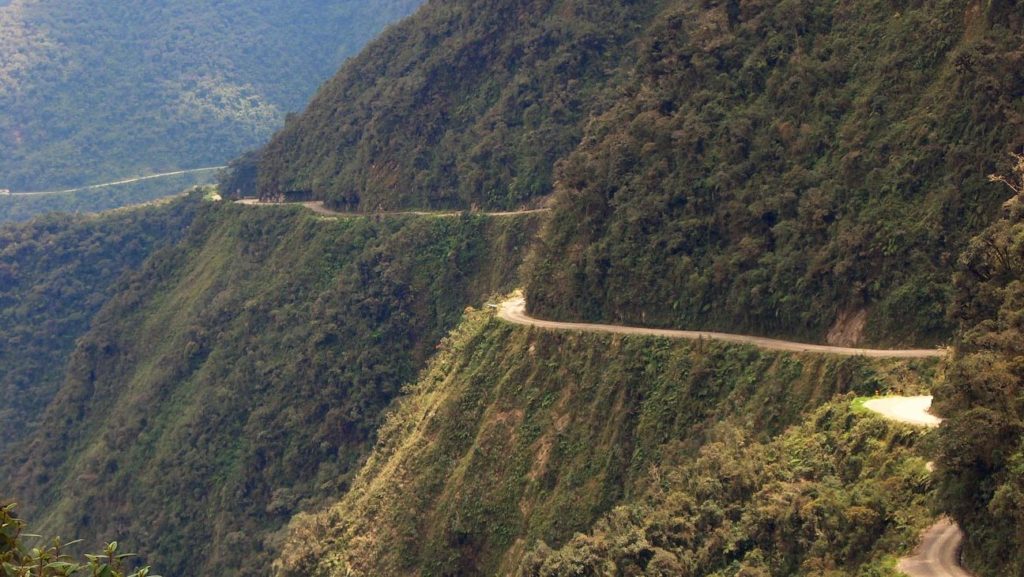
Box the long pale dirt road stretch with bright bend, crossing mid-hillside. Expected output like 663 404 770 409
498 298 946 359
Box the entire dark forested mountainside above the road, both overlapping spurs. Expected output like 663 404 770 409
246 0 1024 345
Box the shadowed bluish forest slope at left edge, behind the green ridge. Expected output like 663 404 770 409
0 195 201 459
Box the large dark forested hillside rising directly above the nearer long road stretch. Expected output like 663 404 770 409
527 0 1024 345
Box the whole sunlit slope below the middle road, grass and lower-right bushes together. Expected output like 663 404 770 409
278 312 936 577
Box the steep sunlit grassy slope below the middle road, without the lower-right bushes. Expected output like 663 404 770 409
279 312 935 576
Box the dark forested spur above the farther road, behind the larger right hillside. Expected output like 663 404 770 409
252 0 656 210
